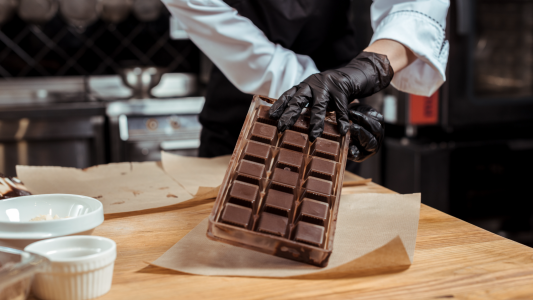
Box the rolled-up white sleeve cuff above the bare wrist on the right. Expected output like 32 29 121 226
370 0 450 96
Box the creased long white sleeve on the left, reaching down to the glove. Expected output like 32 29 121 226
162 0 319 98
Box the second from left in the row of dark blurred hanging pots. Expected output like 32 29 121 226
18 0 59 24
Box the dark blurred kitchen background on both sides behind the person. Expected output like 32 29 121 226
0 0 533 246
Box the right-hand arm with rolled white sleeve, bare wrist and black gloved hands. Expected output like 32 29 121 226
270 0 449 161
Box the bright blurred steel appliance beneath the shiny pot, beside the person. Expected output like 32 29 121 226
107 97 205 162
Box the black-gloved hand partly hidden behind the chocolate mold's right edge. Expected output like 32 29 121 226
348 103 385 162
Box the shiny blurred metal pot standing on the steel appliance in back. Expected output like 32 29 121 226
119 67 165 99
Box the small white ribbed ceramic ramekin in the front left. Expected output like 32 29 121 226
24 235 117 300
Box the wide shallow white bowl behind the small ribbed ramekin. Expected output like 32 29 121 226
0 194 104 249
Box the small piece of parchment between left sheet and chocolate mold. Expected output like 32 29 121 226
161 152 231 199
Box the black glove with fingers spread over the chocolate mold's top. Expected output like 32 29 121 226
270 52 394 145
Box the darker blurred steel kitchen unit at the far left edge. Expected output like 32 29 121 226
0 77 106 176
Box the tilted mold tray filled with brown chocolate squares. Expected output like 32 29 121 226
207 96 349 266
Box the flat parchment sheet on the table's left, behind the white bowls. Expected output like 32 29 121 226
17 162 193 214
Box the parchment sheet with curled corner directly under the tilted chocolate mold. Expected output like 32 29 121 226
152 194 420 278
